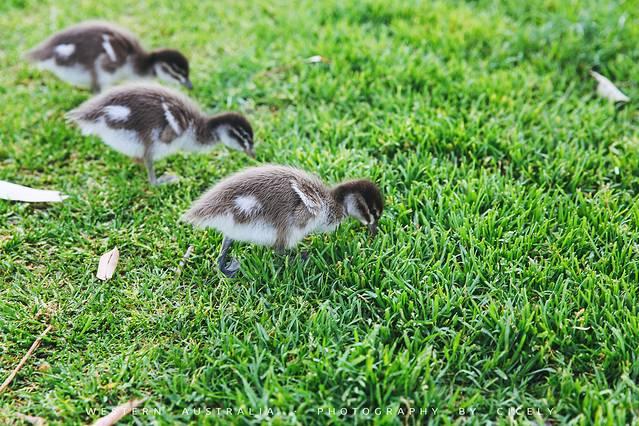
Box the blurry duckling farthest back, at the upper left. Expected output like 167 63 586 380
26 21 193 92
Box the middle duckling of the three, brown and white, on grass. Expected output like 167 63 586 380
67 83 255 185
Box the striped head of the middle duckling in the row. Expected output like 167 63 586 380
208 112 255 158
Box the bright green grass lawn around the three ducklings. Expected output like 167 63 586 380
0 0 639 425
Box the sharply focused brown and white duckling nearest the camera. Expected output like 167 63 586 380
182 165 384 277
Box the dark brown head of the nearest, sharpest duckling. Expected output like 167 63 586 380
333 179 384 235
